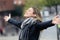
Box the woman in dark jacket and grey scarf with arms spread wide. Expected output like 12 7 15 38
4 7 60 40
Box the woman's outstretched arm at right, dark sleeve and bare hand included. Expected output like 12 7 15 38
35 16 60 30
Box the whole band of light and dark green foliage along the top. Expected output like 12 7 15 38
25 0 60 13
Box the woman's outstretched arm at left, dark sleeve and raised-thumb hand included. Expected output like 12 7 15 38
4 14 22 28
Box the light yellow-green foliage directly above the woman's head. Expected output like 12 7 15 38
25 0 46 9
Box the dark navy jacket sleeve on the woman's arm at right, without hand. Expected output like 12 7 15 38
34 20 55 30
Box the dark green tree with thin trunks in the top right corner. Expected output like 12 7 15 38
45 0 60 13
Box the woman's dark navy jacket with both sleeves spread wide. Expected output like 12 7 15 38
8 18 54 40
